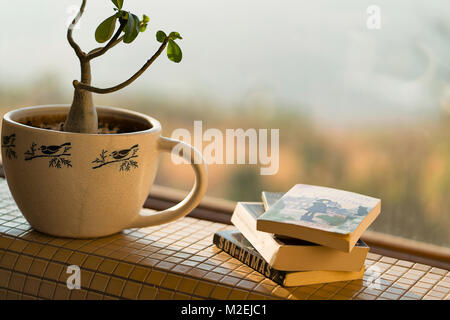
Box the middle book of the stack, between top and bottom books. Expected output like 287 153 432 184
231 202 369 271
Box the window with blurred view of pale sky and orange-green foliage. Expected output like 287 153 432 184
0 0 450 247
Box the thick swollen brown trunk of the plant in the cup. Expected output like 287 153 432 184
64 61 98 133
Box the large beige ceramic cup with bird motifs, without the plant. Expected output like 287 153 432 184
2 106 207 238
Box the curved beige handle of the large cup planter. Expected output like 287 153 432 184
129 136 208 228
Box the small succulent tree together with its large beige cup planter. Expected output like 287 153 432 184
2 0 207 238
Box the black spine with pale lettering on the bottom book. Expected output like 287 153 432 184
213 233 286 286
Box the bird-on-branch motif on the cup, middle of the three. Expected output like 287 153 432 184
25 142 72 169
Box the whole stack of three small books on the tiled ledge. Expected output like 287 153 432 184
214 184 381 286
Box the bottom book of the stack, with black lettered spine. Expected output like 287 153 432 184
213 230 364 287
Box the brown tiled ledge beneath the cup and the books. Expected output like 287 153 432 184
0 179 450 300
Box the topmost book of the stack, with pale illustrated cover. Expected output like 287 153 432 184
256 184 381 252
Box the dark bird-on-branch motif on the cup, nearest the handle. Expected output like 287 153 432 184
92 144 139 171
